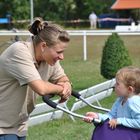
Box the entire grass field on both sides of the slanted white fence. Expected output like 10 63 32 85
0 36 140 140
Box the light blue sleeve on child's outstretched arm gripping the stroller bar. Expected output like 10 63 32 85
98 98 120 121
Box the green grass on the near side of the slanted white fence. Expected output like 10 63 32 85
28 95 115 140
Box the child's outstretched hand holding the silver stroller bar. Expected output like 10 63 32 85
84 112 99 123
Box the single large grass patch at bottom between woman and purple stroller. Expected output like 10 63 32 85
28 117 93 140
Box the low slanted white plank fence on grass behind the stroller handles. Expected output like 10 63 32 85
29 79 115 126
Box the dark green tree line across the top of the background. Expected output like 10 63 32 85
0 0 140 28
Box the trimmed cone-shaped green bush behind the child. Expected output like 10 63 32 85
101 33 132 79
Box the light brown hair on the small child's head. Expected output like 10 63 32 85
116 66 140 94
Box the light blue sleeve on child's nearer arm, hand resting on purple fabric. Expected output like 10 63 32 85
117 99 140 129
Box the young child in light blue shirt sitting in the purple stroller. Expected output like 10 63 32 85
84 66 140 129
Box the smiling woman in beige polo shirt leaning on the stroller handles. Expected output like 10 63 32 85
0 18 71 140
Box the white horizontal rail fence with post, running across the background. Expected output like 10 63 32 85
0 30 140 61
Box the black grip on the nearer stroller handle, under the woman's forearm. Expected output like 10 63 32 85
42 94 57 108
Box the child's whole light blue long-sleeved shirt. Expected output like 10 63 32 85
98 95 140 129
